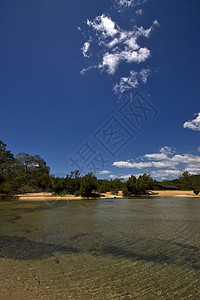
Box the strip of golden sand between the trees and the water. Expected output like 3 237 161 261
18 190 200 201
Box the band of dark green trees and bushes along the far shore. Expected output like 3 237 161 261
0 141 200 199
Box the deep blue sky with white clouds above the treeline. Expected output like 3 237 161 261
0 0 200 180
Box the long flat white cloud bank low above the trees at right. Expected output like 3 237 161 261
113 146 200 178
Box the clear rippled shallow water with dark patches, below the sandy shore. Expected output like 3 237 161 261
0 198 200 300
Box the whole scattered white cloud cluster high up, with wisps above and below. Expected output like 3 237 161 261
78 0 159 97
